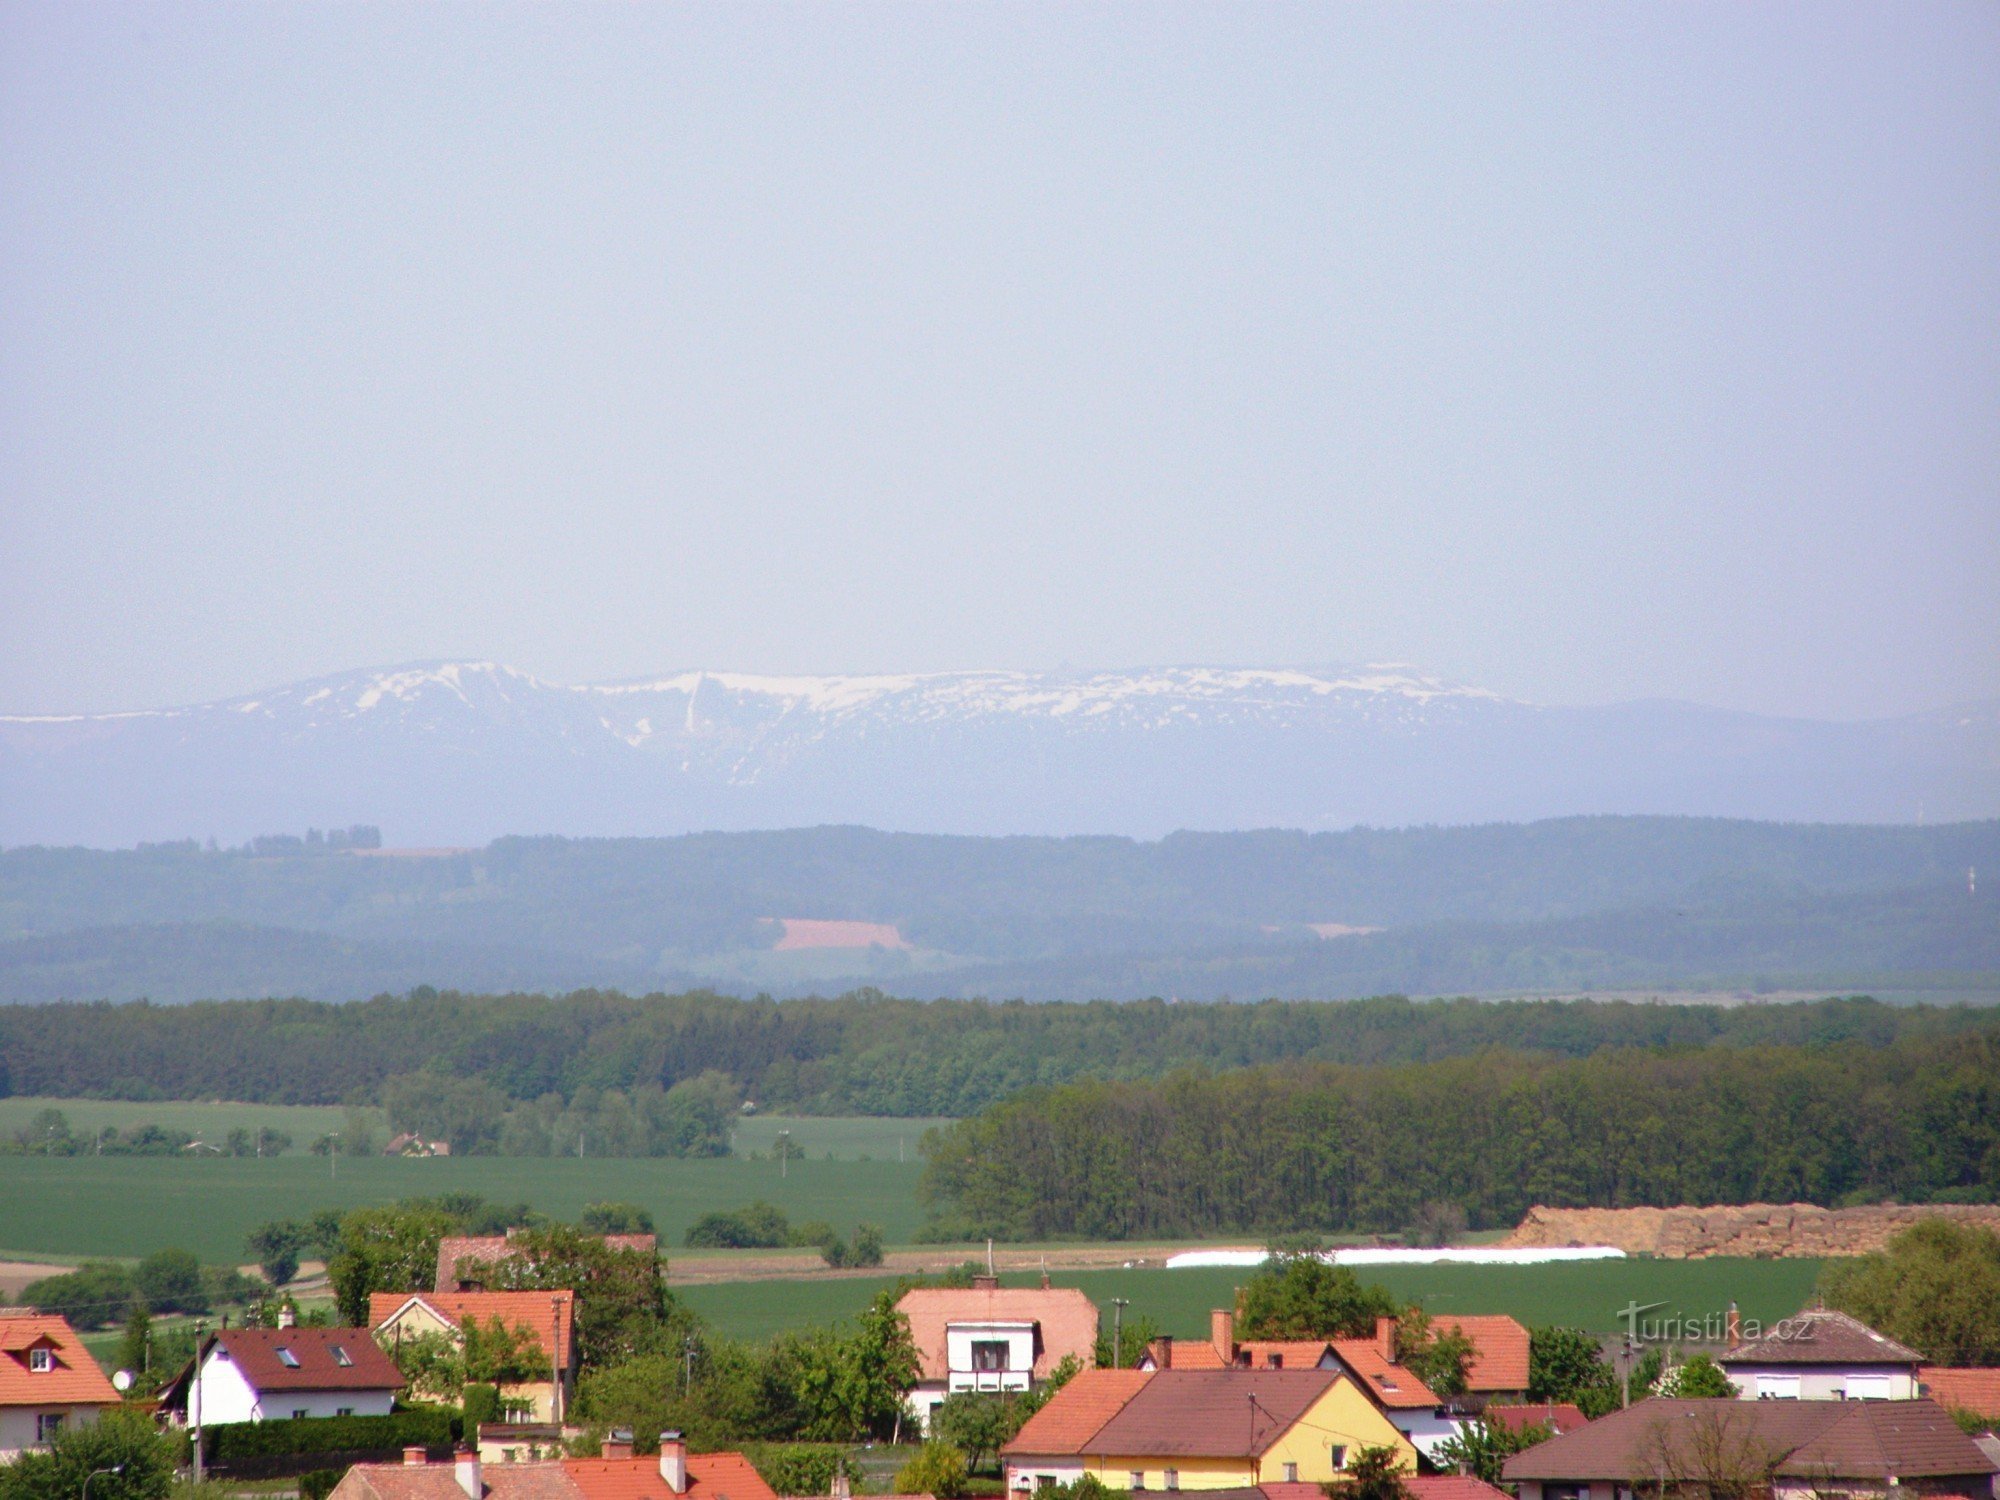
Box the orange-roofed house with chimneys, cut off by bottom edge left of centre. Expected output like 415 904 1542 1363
332 1432 778 1500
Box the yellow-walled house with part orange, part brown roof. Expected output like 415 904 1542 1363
1000 1368 1416 1492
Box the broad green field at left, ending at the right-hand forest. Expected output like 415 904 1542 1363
0 1154 924 1264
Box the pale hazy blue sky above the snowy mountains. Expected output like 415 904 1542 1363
0 0 2000 716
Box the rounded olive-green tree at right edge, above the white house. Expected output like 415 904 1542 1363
1820 1224 2000 1364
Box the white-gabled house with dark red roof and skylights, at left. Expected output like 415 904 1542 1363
160 1328 404 1428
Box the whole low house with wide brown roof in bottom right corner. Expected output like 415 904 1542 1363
1502 1396 2000 1500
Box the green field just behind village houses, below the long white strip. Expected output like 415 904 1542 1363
680 1260 1820 1340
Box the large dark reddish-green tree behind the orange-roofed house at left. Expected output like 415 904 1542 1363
486 1224 694 1370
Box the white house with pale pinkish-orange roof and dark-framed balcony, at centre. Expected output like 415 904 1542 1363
896 1276 1098 1432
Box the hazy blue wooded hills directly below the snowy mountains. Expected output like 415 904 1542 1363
0 818 2000 1000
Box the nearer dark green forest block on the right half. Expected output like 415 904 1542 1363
924 1016 2000 1240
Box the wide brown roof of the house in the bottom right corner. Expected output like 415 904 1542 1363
1504 1396 2000 1488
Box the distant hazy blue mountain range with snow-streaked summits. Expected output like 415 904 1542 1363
0 662 2000 846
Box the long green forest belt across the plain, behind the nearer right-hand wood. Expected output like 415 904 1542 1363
0 992 1996 1118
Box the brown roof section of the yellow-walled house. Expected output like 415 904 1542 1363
1084 1370 1342 1458
